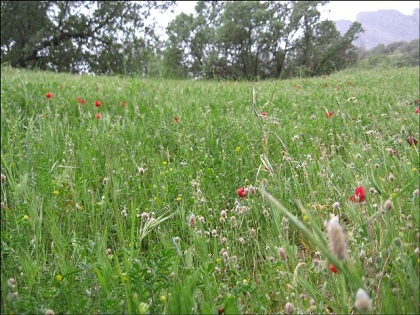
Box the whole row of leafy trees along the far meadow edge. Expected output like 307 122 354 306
1 1 363 80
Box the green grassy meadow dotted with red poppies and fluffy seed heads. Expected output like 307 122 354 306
1 67 420 314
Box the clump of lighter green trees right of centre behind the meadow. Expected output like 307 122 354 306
165 1 362 79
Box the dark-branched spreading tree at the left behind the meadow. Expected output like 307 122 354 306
1 1 173 74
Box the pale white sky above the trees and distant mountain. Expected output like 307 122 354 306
169 1 419 22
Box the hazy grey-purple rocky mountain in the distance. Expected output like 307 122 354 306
335 9 420 50
